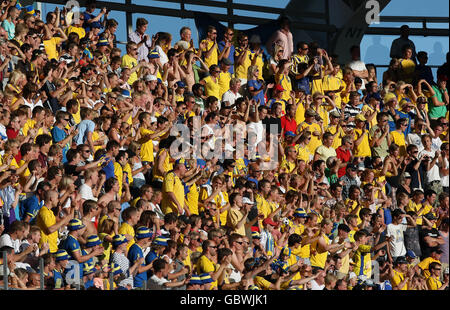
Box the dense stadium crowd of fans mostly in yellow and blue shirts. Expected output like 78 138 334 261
0 0 449 290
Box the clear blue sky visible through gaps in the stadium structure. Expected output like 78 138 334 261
42 0 449 74
